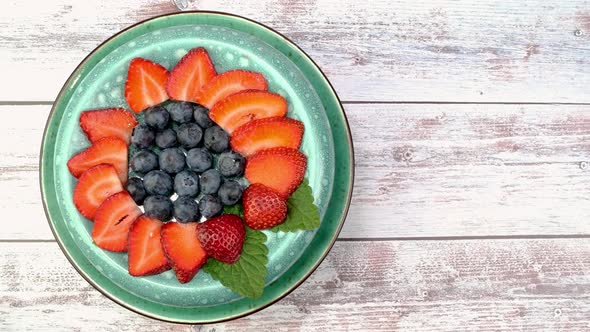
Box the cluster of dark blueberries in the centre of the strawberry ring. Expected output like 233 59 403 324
127 101 246 222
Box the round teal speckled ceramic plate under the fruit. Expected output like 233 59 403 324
40 12 354 323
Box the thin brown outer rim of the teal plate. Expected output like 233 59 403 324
39 10 355 324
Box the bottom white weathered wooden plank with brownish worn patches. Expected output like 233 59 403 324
0 239 590 331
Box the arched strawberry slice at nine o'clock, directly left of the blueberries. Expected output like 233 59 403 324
68 137 127 183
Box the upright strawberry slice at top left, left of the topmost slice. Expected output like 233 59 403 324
125 58 168 113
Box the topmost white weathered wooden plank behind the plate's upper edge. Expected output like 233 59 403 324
0 0 590 103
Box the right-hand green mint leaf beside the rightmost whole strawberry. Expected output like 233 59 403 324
270 179 320 232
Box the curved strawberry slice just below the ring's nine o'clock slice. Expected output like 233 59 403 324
74 164 123 220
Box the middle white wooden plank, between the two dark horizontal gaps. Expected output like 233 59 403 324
0 104 590 239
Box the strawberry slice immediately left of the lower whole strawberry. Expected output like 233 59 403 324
162 222 207 284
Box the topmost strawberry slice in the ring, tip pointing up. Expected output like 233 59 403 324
166 47 217 101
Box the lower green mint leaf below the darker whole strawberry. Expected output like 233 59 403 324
203 227 268 298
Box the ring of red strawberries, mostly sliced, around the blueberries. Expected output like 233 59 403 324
67 47 320 284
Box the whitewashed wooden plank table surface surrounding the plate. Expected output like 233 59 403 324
0 0 590 332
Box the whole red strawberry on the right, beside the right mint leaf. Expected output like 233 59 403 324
242 183 287 229
